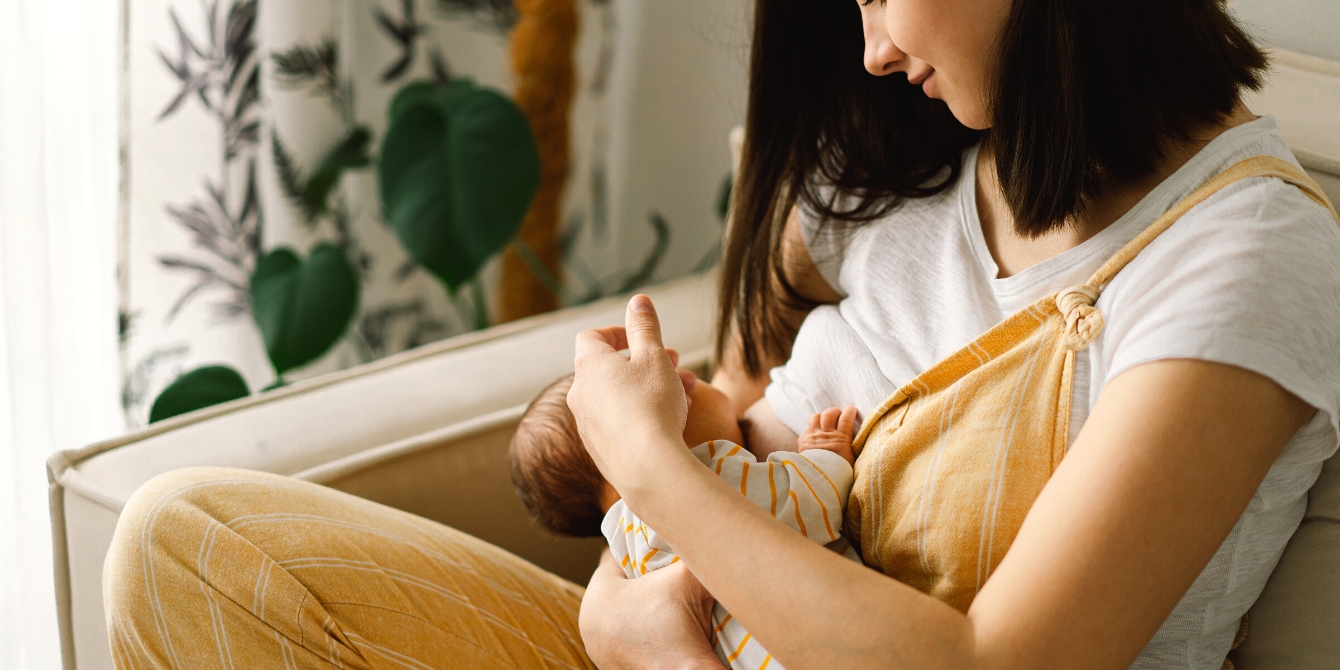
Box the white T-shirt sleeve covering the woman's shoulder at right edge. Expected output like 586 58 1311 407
1099 157 1340 427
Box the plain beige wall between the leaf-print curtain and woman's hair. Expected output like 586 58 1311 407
610 0 753 277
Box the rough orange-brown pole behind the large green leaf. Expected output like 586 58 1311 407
498 0 578 322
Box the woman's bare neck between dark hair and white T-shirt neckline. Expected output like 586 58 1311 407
977 102 1257 279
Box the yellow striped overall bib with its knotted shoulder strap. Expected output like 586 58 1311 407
847 157 1340 621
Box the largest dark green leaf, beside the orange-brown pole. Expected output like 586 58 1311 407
378 79 540 292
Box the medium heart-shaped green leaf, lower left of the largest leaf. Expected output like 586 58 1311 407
251 243 359 377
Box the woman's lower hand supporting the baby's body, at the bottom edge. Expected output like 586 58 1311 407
578 552 722 670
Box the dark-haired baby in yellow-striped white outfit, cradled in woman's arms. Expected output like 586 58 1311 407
511 375 860 670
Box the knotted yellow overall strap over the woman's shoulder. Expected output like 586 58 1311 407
1056 155 1340 351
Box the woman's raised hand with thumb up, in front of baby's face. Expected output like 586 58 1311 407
568 295 695 497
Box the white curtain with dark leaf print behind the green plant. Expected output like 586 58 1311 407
122 0 635 426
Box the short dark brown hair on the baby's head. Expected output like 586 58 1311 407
511 375 604 537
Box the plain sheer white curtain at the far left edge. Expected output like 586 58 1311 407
0 0 123 669
